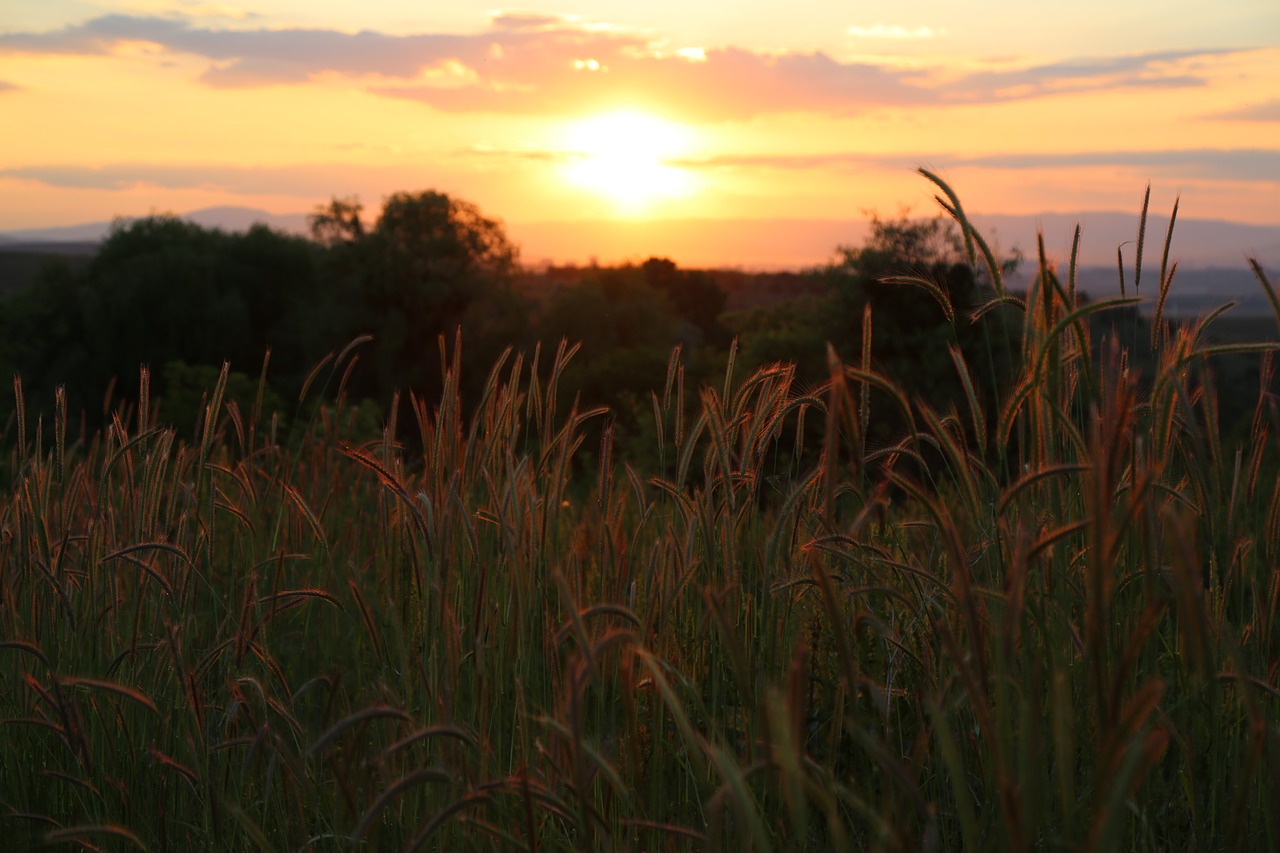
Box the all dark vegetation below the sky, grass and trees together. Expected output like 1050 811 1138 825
0 175 1280 850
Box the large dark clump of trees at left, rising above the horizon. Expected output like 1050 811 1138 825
0 192 527 425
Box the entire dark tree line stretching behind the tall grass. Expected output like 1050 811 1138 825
0 192 1070 466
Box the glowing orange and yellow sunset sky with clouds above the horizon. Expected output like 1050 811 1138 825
0 0 1280 262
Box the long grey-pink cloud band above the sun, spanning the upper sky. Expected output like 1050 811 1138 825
0 12 1249 120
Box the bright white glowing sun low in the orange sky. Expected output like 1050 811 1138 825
563 110 694 215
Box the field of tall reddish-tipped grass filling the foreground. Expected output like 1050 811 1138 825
0 174 1280 850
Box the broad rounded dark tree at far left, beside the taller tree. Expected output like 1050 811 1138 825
4 216 334 420
